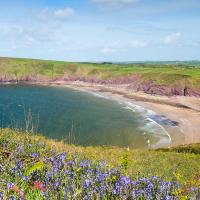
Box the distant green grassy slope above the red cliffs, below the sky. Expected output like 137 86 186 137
0 58 200 89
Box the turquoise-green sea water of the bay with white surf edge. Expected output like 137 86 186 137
0 86 169 148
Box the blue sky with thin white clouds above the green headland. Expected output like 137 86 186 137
0 0 200 62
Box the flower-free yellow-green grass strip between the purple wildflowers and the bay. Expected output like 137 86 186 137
0 129 200 184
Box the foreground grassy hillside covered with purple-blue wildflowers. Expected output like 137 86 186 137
0 129 200 199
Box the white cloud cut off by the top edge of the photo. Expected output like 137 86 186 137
91 0 138 6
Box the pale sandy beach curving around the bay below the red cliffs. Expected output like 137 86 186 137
2 81 200 147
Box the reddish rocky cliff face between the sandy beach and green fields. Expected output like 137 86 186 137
0 73 200 97
